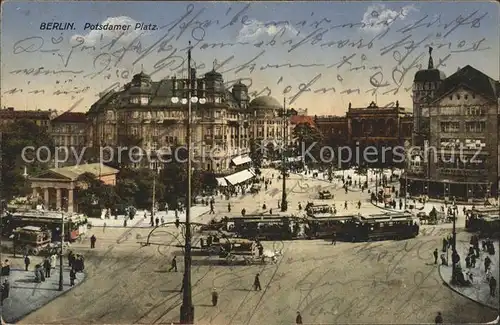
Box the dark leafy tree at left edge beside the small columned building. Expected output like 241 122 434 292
0 120 54 201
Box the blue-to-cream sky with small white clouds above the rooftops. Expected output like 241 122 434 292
1 1 500 115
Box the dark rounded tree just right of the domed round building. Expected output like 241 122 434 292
293 123 326 163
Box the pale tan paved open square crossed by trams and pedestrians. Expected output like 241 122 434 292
12 170 498 325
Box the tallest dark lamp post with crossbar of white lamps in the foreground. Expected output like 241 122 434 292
171 42 206 324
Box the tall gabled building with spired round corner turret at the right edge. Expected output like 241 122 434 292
402 49 500 201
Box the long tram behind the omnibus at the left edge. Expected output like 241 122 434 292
1 210 87 242
